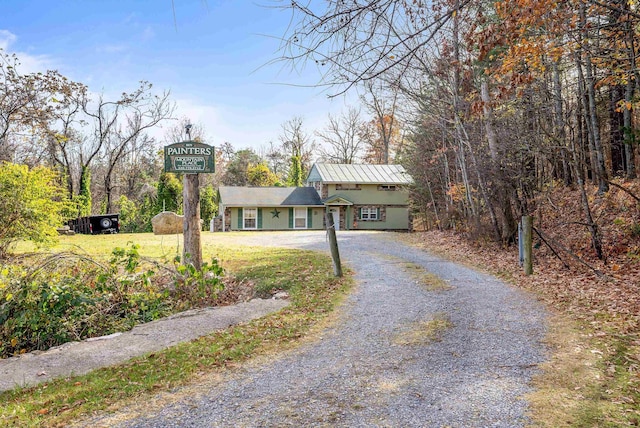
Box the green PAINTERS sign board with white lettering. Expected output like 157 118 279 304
164 141 215 174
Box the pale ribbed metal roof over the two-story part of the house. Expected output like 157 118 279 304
307 163 412 184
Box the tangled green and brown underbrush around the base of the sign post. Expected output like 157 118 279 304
0 245 225 358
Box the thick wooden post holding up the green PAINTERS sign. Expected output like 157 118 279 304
182 174 202 270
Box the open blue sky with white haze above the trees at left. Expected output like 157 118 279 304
0 0 354 153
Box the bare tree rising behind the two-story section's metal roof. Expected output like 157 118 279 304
316 107 363 164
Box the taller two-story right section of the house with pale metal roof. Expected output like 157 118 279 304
307 163 412 230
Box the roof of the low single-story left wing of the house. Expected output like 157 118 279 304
218 186 324 207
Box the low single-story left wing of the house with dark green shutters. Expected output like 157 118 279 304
218 186 324 231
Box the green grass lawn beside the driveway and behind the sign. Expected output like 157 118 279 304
0 233 353 427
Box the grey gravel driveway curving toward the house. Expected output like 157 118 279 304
91 232 546 427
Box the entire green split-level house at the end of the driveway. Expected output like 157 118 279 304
212 163 411 231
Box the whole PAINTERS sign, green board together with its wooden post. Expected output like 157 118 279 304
164 135 215 270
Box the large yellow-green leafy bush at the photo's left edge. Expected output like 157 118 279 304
0 162 71 259
